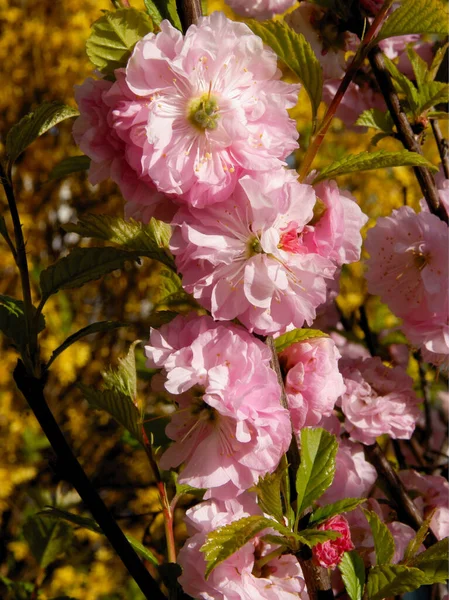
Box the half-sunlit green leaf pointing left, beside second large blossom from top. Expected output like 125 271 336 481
64 215 176 270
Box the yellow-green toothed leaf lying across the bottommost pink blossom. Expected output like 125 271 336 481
200 515 291 579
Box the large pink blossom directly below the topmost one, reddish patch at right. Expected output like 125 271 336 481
170 169 336 335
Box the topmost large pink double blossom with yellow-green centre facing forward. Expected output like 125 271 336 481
120 13 298 207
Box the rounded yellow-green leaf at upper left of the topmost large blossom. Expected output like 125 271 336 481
86 8 153 75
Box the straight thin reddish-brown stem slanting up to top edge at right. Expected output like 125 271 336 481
299 0 393 181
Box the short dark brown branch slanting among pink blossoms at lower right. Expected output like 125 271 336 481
364 443 437 547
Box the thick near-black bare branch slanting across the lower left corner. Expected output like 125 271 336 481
14 360 165 600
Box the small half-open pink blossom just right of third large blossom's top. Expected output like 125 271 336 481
279 338 346 433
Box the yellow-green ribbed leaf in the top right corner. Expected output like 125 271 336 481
373 0 448 44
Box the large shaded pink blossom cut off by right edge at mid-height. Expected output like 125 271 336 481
365 206 449 367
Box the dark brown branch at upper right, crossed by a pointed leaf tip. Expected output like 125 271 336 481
368 46 448 223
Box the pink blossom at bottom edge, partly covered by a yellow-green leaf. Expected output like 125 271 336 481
178 494 305 600
